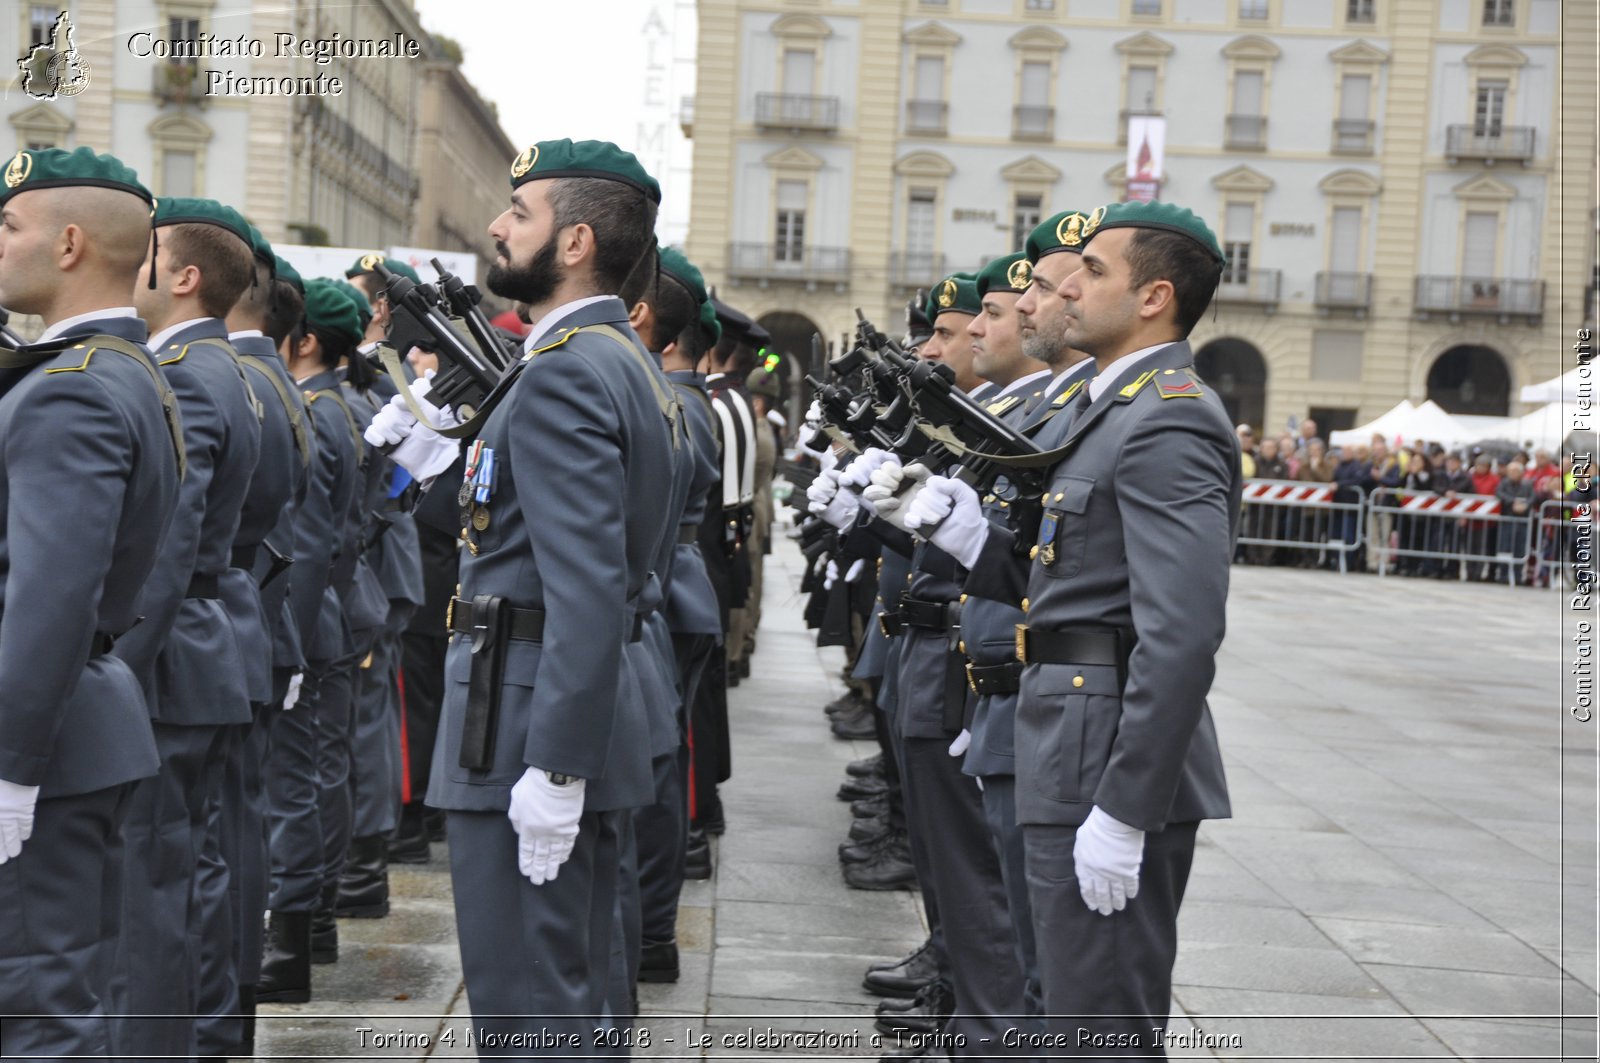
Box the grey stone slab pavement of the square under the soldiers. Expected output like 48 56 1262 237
259 536 1597 1060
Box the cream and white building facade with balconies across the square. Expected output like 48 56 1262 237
686 0 1597 431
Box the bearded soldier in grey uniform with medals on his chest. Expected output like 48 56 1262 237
368 141 677 1057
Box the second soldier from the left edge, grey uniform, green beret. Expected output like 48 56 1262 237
112 199 261 1057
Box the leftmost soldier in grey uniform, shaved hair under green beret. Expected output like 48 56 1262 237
0 147 182 1058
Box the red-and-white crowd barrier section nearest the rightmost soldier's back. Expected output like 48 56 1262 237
1238 480 1366 572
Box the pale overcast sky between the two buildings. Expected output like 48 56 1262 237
416 0 694 243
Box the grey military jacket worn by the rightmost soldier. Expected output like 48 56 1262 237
974 343 1242 831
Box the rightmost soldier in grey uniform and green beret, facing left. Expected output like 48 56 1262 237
906 203 1240 1058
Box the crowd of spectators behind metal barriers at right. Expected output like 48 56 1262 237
1235 419 1595 586
